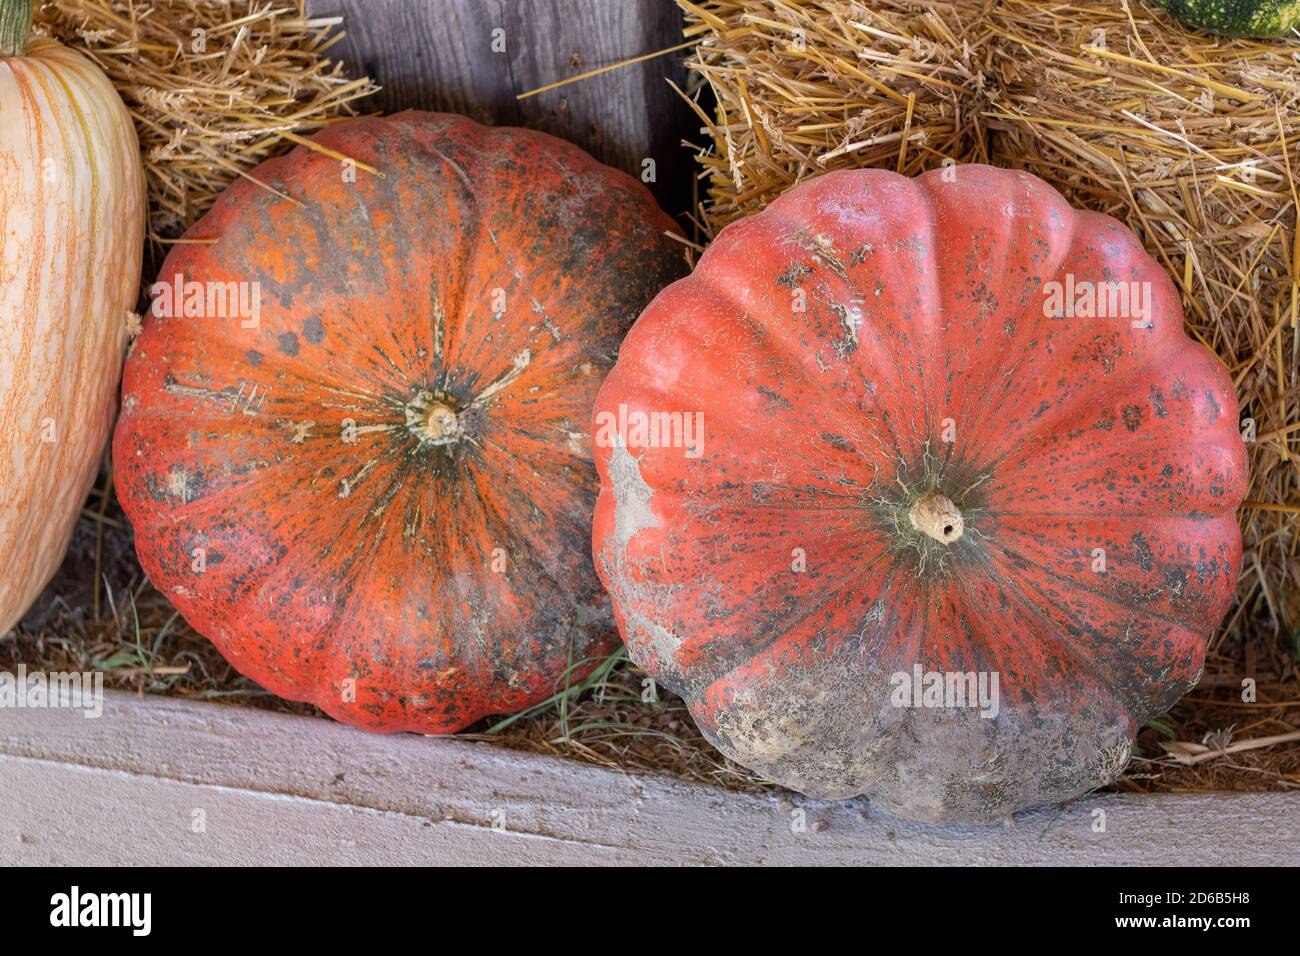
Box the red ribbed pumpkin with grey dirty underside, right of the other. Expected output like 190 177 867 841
594 166 1245 821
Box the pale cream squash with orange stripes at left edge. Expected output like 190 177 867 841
0 0 144 635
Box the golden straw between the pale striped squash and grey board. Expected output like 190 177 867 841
36 0 377 242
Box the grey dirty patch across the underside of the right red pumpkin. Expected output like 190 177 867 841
689 641 1134 825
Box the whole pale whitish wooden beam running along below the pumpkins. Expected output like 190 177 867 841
0 692 1300 865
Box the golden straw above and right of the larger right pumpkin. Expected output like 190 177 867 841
679 0 1300 791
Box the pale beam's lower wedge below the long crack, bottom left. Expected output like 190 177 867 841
0 760 629 866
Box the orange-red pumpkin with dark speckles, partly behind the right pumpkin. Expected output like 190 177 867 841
114 112 683 734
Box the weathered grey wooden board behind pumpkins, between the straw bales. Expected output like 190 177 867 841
307 0 699 213
